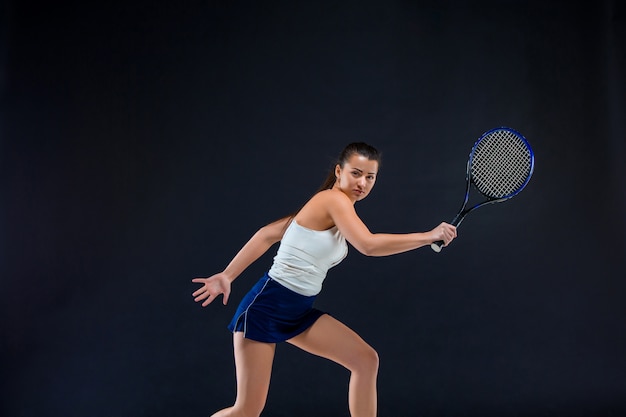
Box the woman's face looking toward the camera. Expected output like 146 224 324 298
334 154 378 203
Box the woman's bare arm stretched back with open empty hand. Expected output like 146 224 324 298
192 217 291 307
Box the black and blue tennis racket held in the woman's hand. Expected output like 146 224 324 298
430 127 535 252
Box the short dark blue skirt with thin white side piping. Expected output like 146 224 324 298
228 273 326 343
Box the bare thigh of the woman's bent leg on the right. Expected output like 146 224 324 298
287 314 378 370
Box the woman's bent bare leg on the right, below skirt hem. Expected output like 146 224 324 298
287 314 378 417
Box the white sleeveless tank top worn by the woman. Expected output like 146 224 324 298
268 220 348 296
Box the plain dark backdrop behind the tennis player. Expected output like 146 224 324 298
0 0 626 417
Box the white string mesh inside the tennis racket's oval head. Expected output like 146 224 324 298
471 130 532 198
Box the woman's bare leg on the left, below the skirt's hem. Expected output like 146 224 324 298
211 332 276 417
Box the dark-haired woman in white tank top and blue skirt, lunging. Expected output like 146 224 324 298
192 143 456 417
